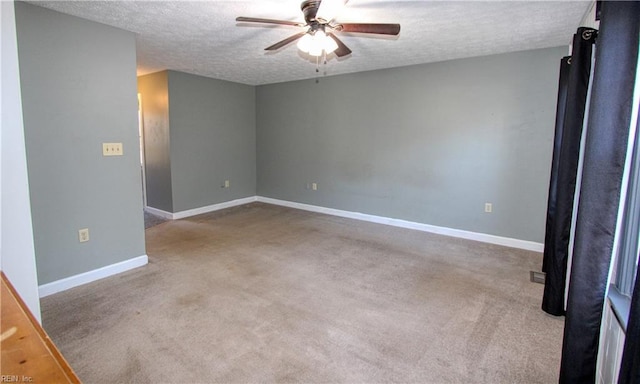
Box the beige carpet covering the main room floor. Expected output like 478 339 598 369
42 203 563 383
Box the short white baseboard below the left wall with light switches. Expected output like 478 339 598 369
38 255 149 297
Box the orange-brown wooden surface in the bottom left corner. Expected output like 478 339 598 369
0 272 80 383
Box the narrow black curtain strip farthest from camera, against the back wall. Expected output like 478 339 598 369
542 56 571 272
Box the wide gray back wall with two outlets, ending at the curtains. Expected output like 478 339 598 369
256 47 566 242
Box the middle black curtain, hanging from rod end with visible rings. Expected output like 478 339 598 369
542 28 597 316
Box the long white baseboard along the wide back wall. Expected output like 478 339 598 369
257 196 544 252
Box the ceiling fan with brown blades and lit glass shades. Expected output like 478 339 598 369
236 0 400 57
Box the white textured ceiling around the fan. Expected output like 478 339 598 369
30 0 590 85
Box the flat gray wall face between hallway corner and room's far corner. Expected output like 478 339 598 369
169 71 256 212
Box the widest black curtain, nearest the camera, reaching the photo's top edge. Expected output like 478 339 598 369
560 1 640 383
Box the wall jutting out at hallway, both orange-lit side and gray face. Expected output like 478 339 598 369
138 71 256 212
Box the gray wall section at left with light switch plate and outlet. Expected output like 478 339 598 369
15 2 145 284
